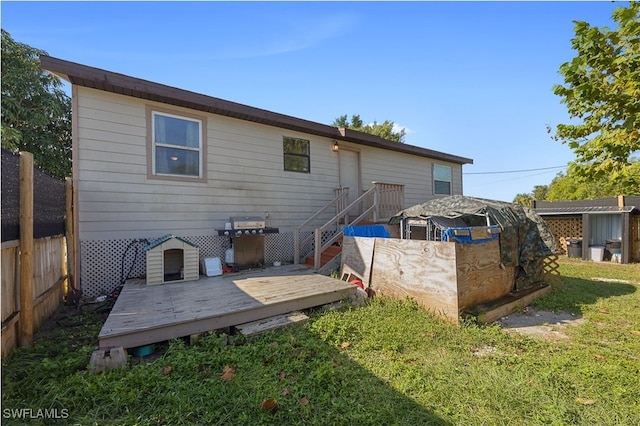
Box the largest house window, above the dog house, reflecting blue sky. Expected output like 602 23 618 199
151 111 203 178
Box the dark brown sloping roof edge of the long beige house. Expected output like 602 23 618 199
40 55 473 164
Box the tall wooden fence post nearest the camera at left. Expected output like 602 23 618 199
19 152 34 346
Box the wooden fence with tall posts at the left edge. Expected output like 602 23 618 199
1 153 72 357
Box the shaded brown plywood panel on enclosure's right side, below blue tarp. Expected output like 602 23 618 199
455 239 514 309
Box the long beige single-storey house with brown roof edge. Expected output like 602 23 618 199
40 56 472 295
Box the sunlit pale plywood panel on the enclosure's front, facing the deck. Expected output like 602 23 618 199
371 238 458 323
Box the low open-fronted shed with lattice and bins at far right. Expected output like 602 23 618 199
533 195 640 263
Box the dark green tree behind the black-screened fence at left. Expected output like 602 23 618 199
1 30 71 177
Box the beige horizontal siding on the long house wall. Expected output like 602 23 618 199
75 87 462 240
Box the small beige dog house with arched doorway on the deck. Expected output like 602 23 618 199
146 235 200 285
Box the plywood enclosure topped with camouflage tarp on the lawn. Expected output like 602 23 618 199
341 196 557 323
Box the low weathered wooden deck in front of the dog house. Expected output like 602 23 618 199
98 265 356 348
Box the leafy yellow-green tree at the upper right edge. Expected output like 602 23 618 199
549 2 640 194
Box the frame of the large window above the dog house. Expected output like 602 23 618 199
147 107 206 181
